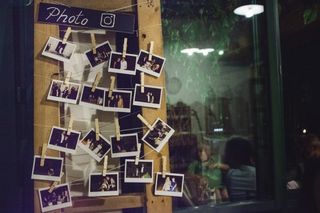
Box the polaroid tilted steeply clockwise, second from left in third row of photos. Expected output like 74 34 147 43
78 129 111 162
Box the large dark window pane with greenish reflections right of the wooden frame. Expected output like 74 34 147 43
162 0 272 207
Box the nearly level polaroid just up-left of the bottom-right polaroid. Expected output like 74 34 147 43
124 159 153 183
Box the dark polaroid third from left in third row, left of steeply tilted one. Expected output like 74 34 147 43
110 133 138 158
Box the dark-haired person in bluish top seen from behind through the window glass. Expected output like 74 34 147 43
224 137 256 201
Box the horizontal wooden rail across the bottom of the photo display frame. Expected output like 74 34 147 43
64 193 145 213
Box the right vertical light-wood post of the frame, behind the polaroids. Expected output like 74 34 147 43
137 0 172 213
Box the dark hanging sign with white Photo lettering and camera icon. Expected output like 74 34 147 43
38 3 135 33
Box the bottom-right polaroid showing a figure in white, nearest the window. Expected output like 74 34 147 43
154 172 184 197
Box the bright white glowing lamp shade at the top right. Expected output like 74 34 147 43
233 0 264 18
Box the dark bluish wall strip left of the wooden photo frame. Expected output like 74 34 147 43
0 1 33 213
